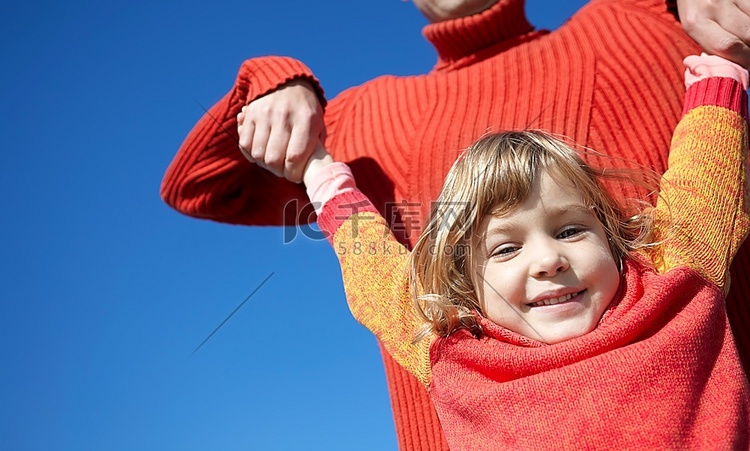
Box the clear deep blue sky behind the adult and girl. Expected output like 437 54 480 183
0 0 583 450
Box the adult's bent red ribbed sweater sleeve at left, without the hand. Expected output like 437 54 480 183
161 57 325 225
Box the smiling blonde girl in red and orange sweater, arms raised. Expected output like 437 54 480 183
266 56 750 450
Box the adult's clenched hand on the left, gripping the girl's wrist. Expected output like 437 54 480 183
237 79 325 183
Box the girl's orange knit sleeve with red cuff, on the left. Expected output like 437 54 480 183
318 191 431 386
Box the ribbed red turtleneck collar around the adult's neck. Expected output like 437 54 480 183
422 0 534 70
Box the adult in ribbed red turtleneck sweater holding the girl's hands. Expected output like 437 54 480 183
162 0 750 450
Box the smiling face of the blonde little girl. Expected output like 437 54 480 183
474 174 620 344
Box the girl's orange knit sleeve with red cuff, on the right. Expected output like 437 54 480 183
656 78 750 290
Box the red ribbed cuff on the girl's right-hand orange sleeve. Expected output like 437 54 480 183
682 77 747 118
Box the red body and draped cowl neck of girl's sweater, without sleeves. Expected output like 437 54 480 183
430 261 750 450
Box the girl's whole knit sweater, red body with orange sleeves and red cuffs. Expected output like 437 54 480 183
318 78 750 451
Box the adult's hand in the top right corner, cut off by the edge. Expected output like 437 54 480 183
677 0 750 68
